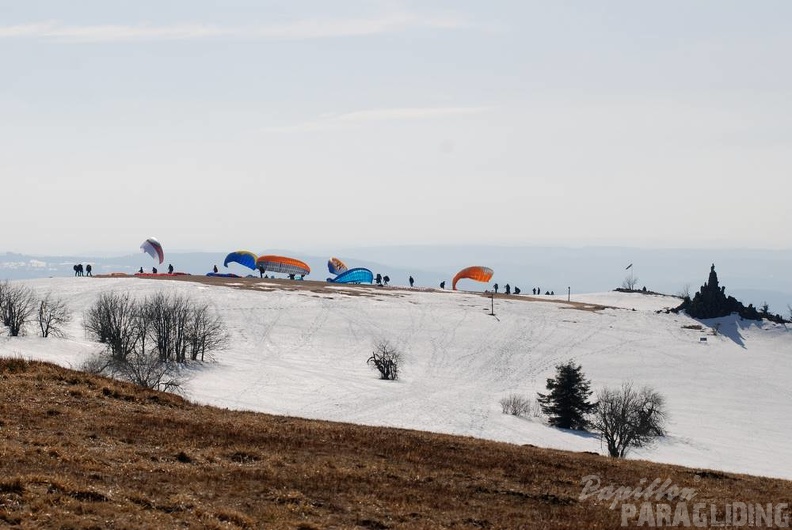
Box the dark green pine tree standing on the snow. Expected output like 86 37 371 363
538 361 597 431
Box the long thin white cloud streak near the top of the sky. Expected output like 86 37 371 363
0 13 469 42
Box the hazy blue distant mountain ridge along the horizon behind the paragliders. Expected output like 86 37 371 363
0 245 792 313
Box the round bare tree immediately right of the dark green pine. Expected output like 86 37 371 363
591 383 668 458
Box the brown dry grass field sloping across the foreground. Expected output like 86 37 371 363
0 359 792 529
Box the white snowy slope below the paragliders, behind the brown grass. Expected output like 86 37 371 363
0 278 792 479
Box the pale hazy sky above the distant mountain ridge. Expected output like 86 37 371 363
0 0 792 254
